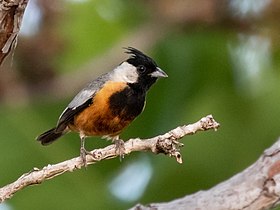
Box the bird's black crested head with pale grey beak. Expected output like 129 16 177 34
125 47 167 89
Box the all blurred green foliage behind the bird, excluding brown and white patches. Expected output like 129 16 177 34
0 1 280 210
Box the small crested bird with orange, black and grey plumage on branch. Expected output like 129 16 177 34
36 47 167 165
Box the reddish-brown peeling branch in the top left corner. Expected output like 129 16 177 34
0 0 28 65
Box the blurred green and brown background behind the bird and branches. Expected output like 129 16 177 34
0 0 280 210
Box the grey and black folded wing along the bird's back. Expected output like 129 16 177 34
56 73 109 131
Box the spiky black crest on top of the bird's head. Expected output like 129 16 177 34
124 47 157 67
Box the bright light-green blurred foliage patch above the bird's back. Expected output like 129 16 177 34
57 0 148 71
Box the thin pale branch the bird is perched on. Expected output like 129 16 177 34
0 115 219 203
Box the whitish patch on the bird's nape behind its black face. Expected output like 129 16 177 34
111 62 138 83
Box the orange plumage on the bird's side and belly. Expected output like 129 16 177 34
69 82 130 136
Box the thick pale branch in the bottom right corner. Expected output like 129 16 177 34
131 138 280 210
